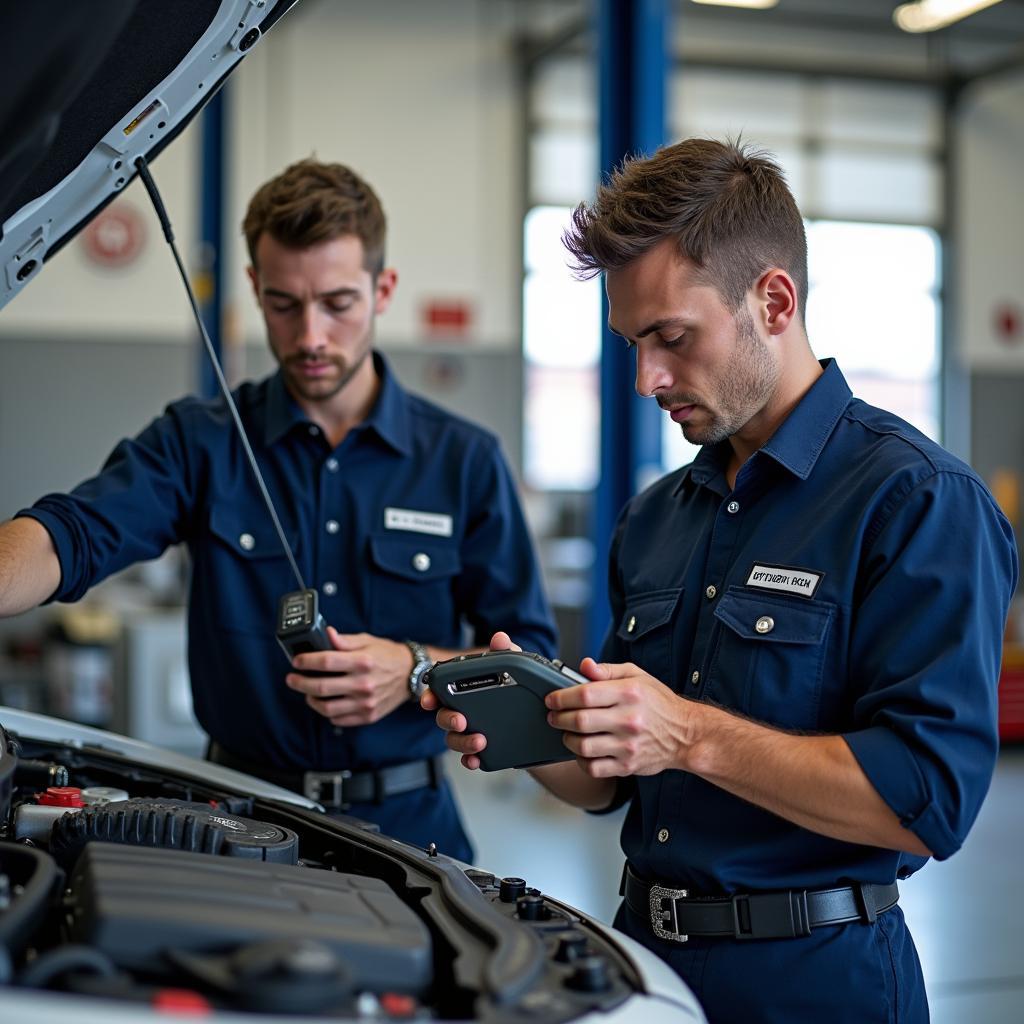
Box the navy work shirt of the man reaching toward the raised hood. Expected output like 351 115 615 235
20 353 556 851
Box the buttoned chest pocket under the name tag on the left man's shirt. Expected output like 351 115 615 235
369 535 462 645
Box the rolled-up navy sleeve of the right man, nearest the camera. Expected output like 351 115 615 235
844 471 1018 860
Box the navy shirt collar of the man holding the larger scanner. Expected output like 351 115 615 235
675 359 853 494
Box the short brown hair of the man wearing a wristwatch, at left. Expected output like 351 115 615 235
242 159 387 278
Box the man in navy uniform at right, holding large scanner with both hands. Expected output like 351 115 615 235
424 139 1018 1024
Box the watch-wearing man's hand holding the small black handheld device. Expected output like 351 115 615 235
285 626 413 726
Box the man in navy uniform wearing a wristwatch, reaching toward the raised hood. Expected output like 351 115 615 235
0 160 556 860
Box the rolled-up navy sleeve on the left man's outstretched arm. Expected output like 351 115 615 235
17 405 191 601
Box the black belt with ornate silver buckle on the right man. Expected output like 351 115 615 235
622 864 899 942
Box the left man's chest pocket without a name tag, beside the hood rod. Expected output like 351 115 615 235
202 506 299 634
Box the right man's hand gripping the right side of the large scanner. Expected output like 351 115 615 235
545 657 690 778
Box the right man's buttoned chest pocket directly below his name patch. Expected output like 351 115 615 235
706 590 836 729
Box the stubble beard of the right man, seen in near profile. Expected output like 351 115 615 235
674 309 779 444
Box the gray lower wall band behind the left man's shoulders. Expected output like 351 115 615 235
0 336 522 519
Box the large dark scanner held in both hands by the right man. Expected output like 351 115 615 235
424 650 590 771
